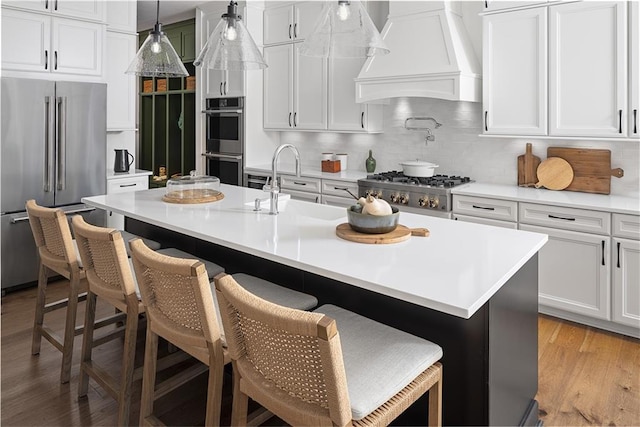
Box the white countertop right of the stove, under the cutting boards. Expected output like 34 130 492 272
451 182 640 215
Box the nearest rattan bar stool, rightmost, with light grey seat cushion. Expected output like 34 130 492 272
215 275 442 426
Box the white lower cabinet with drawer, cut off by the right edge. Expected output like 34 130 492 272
611 214 640 328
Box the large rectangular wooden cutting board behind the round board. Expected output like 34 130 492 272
547 147 624 194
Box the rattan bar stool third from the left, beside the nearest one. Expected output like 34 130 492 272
130 240 317 426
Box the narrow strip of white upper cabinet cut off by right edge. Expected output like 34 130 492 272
628 1 640 138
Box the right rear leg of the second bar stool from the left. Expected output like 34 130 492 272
118 301 138 426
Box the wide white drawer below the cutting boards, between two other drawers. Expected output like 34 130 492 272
519 203 611 234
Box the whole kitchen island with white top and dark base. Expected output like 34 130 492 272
83 184 547 425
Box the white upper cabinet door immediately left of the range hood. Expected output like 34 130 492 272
328 58 382 132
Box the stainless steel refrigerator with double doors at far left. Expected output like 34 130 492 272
0 77 107 290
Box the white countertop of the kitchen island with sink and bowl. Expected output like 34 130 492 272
82 184 547 318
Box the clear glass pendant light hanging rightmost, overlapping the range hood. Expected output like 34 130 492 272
300 0 389 58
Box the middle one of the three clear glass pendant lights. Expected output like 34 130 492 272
193 0 267 70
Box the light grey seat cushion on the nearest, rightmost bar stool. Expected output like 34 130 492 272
312 304 442 420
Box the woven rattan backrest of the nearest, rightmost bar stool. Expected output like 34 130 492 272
216 275 351 426
